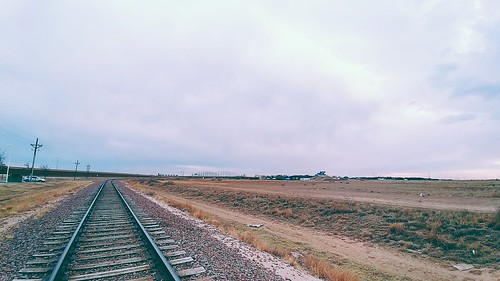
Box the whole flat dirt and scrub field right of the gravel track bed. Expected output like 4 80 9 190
128 179 500 280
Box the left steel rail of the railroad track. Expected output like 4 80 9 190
47 180 109 281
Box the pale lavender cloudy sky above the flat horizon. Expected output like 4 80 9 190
0 0 500 179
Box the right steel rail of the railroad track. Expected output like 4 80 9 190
111 180 181 281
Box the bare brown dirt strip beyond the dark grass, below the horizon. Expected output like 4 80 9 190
171 180 500 213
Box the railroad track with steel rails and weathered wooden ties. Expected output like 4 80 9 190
14 180 205 281
